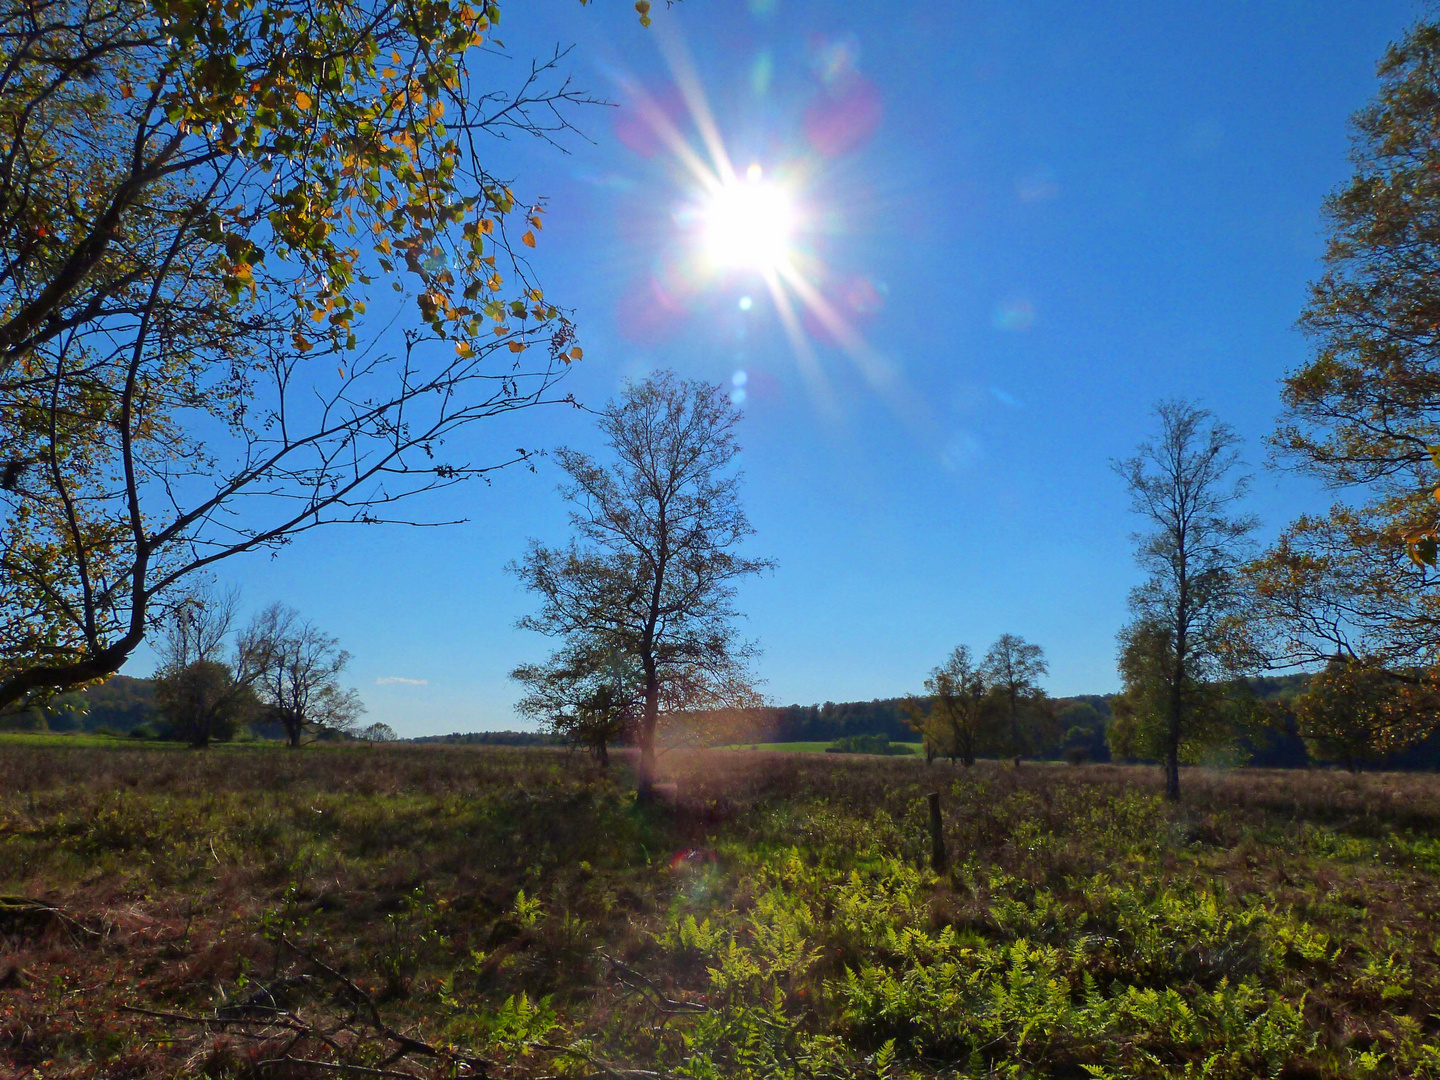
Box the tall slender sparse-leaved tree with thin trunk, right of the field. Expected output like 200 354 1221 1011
1112 400 1256 799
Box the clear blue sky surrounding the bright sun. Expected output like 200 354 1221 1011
130 0 1418 734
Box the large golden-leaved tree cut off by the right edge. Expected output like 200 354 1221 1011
1250 20 1440 670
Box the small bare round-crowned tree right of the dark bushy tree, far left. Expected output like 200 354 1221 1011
236 603 364 746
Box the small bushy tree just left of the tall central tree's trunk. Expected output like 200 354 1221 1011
510 639 645 766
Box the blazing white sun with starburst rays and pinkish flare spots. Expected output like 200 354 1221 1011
613 24 921 432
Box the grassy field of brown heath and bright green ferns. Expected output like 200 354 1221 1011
0 744 1440 1080
